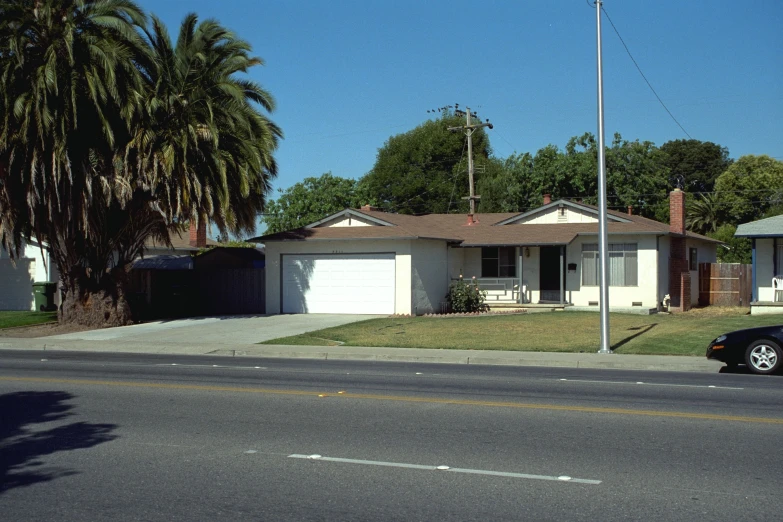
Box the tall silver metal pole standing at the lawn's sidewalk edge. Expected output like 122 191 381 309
595 0 612 353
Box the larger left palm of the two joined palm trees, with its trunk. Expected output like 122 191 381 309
0 0 146 324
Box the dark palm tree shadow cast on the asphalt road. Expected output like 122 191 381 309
0 391 117 495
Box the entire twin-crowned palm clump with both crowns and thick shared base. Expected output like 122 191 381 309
0 4 280 326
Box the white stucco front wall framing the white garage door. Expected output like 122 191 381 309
265 240 422 314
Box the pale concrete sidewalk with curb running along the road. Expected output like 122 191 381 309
0 337 723 373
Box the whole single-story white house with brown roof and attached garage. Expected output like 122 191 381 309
250 190 719 315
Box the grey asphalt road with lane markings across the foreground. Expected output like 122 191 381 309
0 351 783 521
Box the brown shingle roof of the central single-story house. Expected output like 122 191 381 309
253 204 718 247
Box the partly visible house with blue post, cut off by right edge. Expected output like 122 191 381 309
734 216 783 315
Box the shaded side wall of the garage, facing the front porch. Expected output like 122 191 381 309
411 240 449 315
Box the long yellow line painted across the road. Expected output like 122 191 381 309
6 377 783 424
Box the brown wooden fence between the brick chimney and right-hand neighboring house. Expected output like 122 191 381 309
699 263 753 306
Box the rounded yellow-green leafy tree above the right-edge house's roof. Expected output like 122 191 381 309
715 155 783 225
